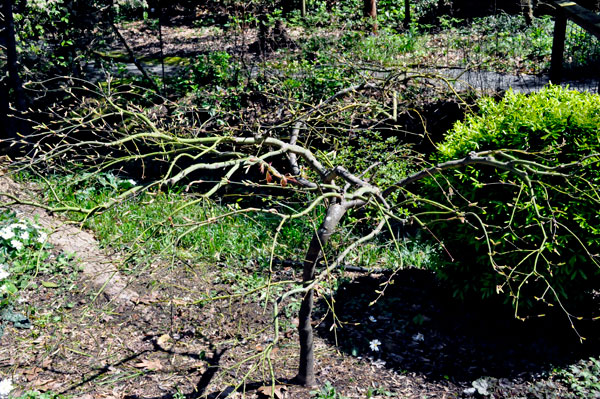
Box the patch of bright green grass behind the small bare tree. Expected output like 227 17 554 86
22 172 437 282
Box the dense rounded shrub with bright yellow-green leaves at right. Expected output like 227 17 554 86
415 86 600 314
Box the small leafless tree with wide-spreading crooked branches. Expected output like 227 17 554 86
2 84 600 386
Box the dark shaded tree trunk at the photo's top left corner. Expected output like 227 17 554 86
2 0 29 148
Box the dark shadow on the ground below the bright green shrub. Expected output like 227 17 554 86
317 269 600 384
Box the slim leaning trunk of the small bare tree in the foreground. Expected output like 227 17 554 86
296 203 347 387
